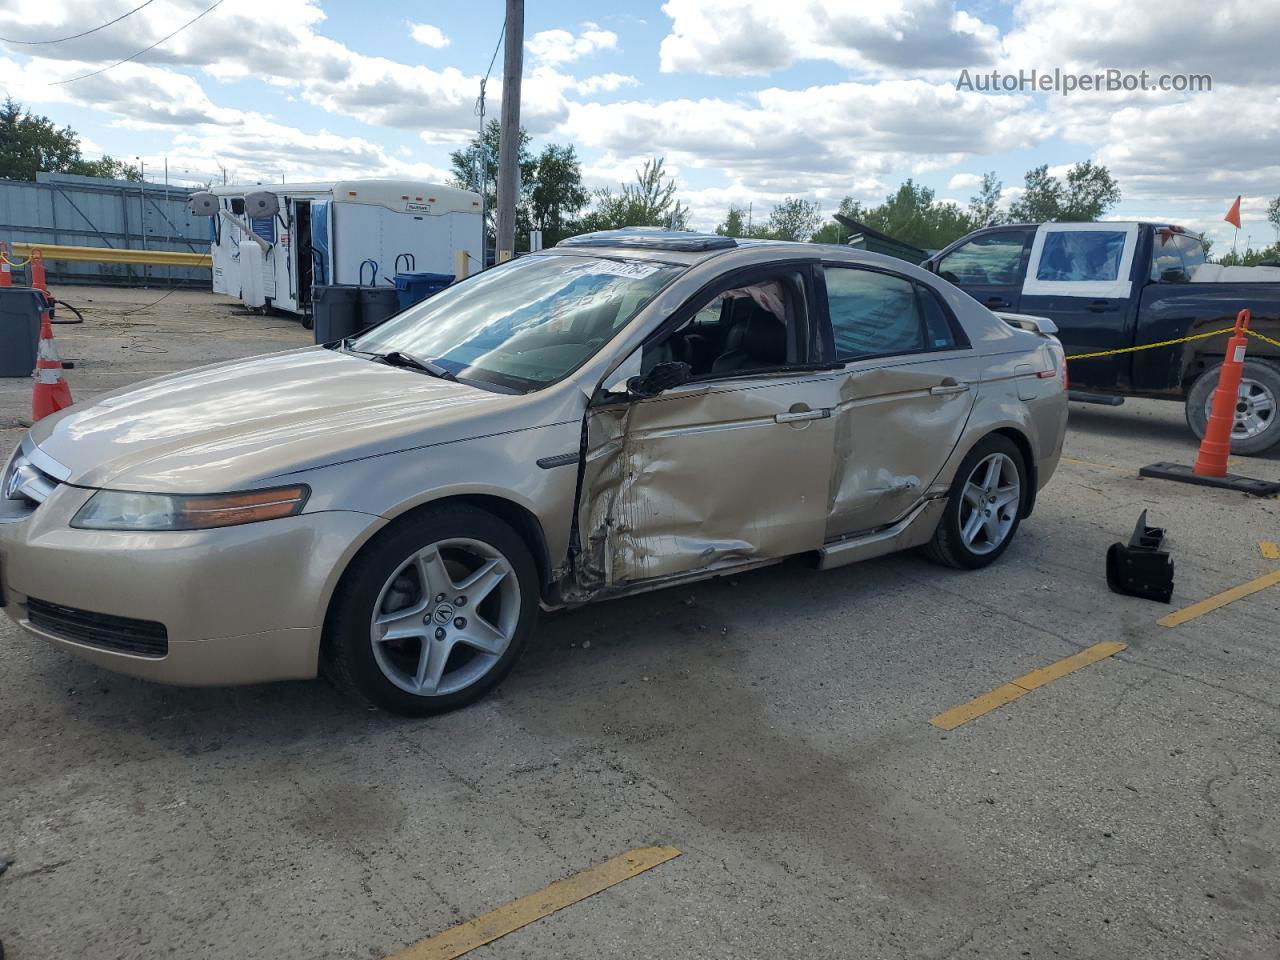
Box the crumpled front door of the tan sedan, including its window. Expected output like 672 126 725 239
577 265 837 593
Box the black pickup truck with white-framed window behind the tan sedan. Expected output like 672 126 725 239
922 221 1280 454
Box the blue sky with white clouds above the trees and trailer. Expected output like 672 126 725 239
0 0 1280 250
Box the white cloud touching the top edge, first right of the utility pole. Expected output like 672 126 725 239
660 0 998 74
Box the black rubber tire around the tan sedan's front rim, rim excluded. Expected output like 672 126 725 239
321 504 539 717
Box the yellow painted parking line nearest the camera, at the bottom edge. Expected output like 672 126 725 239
387 846 680 960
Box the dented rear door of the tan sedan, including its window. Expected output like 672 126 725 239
823 264 980 539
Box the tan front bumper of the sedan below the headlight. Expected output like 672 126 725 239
0 485 385 686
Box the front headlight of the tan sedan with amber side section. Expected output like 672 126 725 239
72 485 311 530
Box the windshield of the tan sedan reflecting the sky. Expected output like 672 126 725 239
351 255 684 390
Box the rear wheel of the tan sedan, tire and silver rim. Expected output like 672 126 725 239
924 434 1027 570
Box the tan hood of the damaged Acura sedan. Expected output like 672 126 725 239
31 347 512 493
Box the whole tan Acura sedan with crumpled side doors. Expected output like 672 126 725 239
0 229 1066 714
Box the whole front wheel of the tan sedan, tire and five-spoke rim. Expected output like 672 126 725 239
325 506 538 717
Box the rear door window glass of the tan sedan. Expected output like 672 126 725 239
824 265 956 360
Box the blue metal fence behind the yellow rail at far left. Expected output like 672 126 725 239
0 173 211 287
